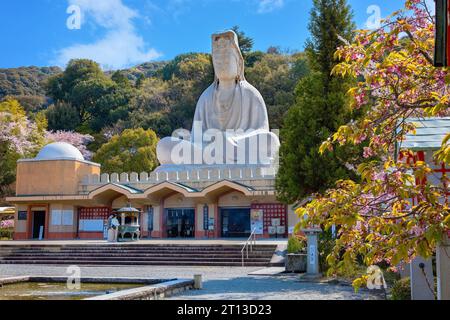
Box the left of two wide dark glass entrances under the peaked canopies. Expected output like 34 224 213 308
166 209 195 238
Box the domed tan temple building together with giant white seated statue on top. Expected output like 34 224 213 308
8 31 298 240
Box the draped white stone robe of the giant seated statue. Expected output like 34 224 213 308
158 80 280 165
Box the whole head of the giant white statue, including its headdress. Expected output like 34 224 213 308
212 30 245 81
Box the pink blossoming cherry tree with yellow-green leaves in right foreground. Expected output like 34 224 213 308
297 0 450 287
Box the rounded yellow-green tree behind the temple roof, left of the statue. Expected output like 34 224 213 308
93 128 158 173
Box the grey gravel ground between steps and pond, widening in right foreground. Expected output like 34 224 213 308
0 265 377 300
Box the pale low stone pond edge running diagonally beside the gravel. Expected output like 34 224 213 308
85 280 194 301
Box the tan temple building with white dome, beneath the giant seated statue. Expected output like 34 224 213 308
8 143 297 240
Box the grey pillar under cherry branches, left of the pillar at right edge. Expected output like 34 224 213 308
410 257 435 300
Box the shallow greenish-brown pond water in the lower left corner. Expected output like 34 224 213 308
0 282 142 300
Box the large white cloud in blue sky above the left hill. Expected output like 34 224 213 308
55 0 160 69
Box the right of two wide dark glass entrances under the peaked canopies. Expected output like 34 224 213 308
220 208 251 238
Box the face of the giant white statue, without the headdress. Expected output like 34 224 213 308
213 38 239 81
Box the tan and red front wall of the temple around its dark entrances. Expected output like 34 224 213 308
8 191 298 240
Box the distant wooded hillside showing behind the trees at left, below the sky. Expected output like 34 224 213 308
0 62 167 112
